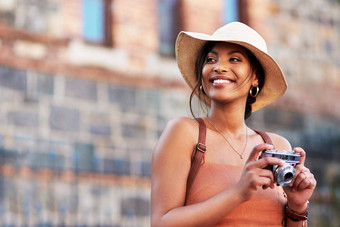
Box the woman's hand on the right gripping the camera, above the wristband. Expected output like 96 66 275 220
283 147 316 212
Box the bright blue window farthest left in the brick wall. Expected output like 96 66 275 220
83 0 112 46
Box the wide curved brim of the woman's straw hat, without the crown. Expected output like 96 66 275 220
176 32 287 112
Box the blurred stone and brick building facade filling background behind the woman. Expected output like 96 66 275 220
0 0 340 226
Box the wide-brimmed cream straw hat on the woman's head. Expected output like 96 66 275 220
176 22 287 112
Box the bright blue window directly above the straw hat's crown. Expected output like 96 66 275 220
224 0 246 23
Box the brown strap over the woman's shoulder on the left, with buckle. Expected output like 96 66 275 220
186 118 207 201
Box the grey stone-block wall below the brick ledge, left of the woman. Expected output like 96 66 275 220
0 66 191 226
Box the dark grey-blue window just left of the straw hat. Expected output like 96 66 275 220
158 0 180 56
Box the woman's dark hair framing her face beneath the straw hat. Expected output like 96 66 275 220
189 41 265 119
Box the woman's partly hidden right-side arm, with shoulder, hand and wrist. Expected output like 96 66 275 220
270 134 316 227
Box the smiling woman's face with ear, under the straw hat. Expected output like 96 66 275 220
202 42 259 109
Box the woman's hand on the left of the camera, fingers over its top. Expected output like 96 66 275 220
235 144 285 201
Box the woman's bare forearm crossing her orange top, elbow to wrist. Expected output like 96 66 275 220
152 187 244 227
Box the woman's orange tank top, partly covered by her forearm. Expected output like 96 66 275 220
186 163 286 227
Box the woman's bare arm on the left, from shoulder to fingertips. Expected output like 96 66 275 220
151 118 283 226
